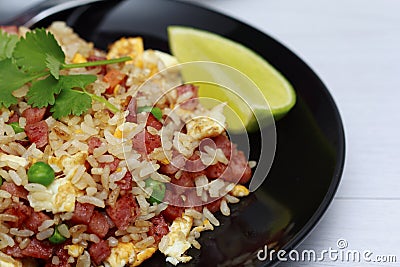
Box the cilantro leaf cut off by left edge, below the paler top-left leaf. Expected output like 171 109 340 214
0 59 34 108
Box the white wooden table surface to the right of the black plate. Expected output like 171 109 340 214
180 0 400 266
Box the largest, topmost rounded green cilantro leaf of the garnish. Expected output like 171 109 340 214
13 29 65 72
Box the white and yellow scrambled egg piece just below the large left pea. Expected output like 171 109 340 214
28 178 77 213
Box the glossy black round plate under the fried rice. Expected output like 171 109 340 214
29 0 345 266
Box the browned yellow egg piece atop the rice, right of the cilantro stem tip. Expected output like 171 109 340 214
107 37 144 67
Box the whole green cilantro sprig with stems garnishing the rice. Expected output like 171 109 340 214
0 29 131 119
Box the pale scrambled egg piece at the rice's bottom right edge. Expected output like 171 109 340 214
159 215 193 265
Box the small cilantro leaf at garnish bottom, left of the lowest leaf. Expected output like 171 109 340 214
26 75 61 108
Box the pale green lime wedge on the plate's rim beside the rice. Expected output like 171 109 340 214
168 26 296 130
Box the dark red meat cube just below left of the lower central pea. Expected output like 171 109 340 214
106 194 140 230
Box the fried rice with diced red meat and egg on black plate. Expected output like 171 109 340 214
0 22 253 267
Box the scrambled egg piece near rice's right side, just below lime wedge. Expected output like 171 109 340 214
186 117 225 140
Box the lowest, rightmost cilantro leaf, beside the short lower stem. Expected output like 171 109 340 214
50 89 92 119
